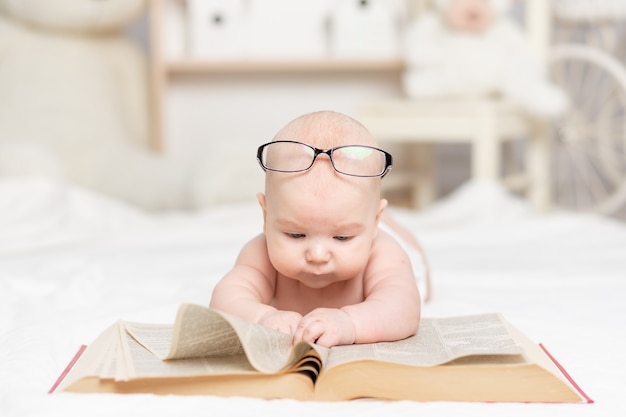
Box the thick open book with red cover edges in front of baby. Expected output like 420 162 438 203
51 304 591 402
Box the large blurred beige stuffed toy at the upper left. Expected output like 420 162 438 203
0 0 217 210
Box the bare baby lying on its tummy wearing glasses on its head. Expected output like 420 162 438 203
210 111 428 346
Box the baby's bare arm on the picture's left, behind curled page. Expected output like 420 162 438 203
210 235 302 335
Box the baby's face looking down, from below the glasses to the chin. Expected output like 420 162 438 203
261 160 385 288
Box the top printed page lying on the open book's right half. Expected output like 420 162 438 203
324 313 523 367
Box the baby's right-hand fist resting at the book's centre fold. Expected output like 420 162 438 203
293 308 356 347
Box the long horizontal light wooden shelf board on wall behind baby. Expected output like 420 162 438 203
163 59 404 74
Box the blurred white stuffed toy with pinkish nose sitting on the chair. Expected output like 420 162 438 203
403 0 568 118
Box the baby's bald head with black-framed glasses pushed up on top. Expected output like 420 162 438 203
259 111 387 287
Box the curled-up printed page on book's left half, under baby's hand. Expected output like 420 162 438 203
127 304 323 374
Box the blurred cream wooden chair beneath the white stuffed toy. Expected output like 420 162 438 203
355 0 550 210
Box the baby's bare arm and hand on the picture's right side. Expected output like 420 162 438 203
294 231 421 346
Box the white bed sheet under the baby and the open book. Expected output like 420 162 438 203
0 179 626 417
